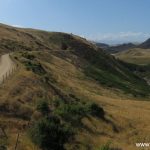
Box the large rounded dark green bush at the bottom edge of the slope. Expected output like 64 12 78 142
29 116 73 150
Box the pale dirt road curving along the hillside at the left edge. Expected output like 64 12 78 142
0 54 15 84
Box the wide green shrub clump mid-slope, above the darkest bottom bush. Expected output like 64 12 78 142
54 100 105 125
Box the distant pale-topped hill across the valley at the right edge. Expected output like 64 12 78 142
114 48 150 84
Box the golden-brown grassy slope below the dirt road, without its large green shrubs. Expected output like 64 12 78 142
0 51 149 150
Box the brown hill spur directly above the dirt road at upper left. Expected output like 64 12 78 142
0 25 50 53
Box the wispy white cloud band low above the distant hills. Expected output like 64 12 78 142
86 31 150 42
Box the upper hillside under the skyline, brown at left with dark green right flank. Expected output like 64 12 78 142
0 23 149 96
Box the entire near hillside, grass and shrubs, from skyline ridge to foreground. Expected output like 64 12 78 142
0 25 150 150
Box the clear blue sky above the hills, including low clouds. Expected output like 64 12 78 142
0 0 150 44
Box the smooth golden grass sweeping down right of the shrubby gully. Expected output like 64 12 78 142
34 51 150 150
